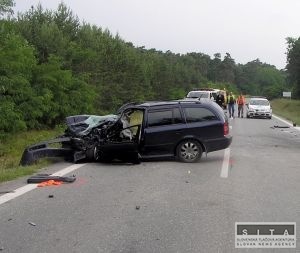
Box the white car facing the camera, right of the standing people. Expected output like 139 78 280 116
247 97 272 119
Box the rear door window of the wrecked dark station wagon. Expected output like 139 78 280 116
148 108 182 127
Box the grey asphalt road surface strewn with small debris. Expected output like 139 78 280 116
0 115 300 253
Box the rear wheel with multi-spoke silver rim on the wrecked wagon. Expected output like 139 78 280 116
176 140 203 163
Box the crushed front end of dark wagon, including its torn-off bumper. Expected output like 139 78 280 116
20 115 118 166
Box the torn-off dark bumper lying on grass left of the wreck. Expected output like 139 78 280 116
20 137 78 166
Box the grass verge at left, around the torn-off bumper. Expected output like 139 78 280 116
0 127 64 182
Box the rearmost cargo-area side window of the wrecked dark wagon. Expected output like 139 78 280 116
184 107 218 123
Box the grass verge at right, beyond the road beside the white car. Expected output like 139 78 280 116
271 99 300 126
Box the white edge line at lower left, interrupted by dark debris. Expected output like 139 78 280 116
0 163 86 205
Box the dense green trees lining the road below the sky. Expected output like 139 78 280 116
0 0 300 136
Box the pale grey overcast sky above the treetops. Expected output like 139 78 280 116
15 0 300 69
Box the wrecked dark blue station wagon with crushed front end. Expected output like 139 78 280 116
21 99 232 165
